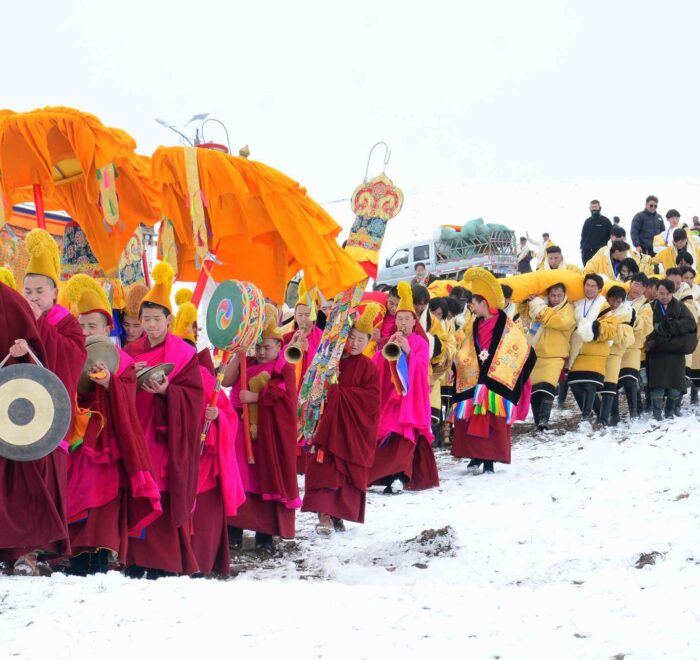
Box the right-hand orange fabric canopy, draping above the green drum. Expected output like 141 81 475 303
152 147 366 301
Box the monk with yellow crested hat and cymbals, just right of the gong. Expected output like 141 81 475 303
65 275 162 575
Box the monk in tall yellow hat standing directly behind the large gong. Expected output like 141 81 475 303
0 229 86 575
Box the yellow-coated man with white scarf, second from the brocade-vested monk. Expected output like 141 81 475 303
567 273 616 420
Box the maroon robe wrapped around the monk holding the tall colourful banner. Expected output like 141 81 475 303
302 355 380 523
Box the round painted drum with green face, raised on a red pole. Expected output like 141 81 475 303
207 280 265 351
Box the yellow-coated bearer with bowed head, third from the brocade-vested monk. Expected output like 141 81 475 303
598 286 634 426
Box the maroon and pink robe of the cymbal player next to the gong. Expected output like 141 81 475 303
68 352 162 564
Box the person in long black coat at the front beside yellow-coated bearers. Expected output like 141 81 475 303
646 279 698 421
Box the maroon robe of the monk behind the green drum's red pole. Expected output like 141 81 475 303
228 355 301 538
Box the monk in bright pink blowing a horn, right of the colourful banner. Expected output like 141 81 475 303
367 282 440 493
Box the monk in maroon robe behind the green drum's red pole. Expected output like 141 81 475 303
223 305 301 553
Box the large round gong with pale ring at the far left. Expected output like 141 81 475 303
0 364 71 461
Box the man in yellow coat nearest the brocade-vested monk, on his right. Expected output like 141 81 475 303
527 284 576 431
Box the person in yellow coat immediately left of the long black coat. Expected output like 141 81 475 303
612 273 654 420
